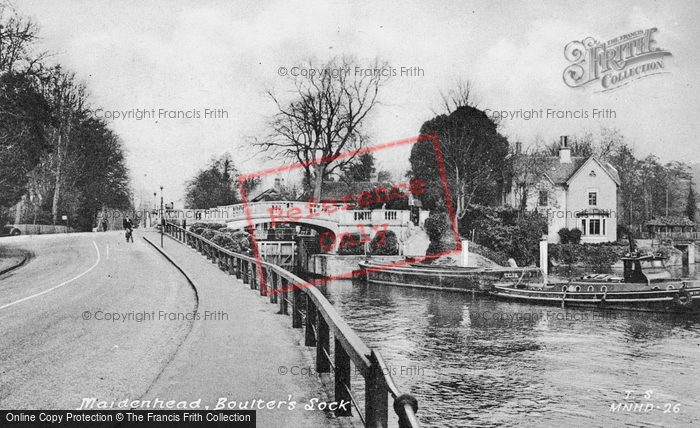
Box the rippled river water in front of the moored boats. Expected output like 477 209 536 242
322 266 700 428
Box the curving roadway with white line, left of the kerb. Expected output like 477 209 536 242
0 231 196 409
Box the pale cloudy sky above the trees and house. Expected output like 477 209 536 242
14 0 700 207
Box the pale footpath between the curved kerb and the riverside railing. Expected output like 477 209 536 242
143 232 340 427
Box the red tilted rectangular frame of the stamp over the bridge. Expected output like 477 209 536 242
238 134 462 296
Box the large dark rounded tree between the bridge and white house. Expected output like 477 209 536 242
410 106 509 219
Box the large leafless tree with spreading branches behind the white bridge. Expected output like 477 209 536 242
253 57 388 199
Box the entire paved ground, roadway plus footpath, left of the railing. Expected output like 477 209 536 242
0 231 342 427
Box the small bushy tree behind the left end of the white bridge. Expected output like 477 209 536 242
185 153 240 209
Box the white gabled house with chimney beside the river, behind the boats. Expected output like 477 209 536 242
506 136 620 243
